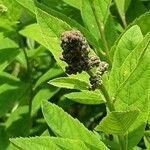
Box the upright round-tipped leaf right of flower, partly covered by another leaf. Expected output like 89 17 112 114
109 25 143 96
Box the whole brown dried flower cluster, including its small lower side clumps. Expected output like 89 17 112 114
60 30 108 90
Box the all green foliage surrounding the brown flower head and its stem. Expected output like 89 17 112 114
0 0 150 150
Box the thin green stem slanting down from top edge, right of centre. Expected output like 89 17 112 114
89 0 110 59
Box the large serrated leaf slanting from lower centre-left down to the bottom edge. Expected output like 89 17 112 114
42 101 107 150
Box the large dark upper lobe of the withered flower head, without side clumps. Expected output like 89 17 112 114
60 30 89 74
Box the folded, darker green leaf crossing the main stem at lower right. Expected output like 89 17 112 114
96 110 139 135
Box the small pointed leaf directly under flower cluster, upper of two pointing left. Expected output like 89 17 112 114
48 77 88 90
